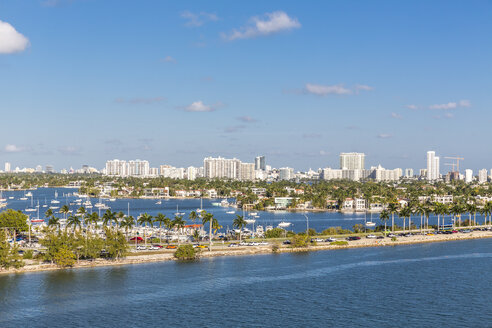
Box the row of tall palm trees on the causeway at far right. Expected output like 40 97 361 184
379 202 492 231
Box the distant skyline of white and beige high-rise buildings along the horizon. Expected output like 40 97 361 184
0 151 492 183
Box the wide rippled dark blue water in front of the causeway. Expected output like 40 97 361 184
0 240 492 327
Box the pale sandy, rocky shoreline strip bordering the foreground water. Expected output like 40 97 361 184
0 231 492 275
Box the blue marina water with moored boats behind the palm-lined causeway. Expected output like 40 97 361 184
3 188 483 232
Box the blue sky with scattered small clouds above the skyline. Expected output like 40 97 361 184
0 0 492 171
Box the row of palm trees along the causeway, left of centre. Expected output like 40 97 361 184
40 205 236 250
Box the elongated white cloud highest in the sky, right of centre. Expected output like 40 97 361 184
222 11 301 41
